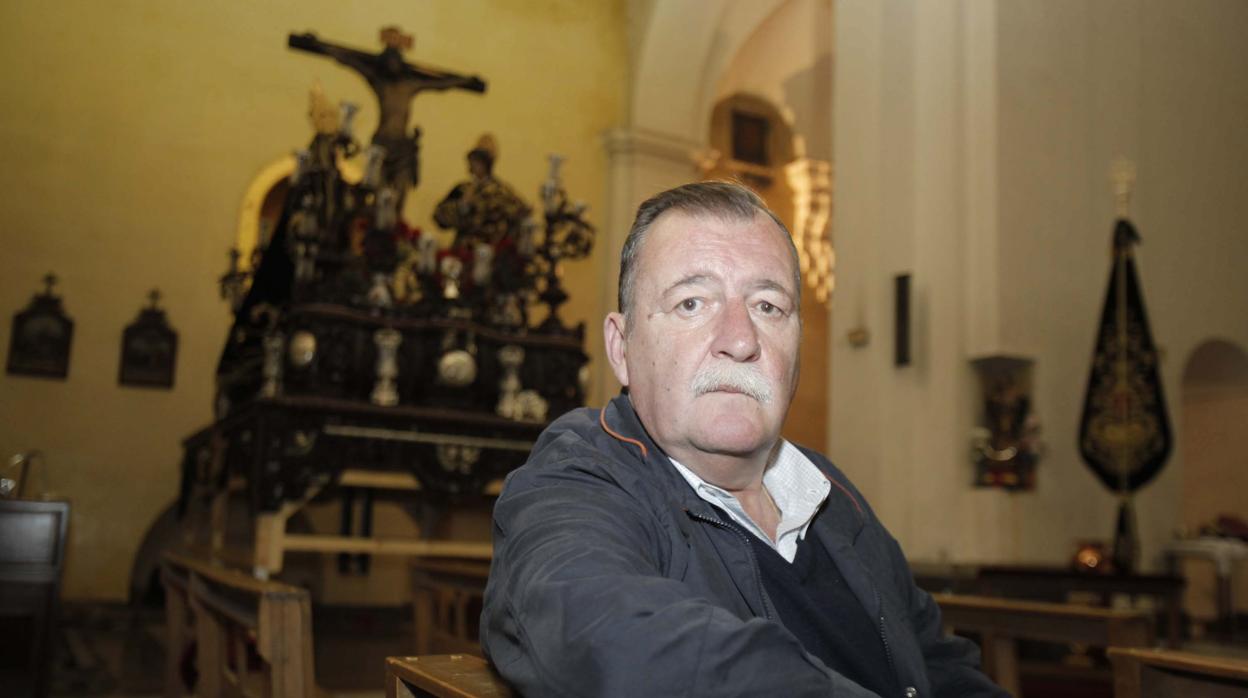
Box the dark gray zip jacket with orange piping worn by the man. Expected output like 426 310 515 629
480 396 1005 697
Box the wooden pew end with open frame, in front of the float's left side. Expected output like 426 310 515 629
161 556 316 698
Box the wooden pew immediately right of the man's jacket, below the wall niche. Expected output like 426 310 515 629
932 594 1154 696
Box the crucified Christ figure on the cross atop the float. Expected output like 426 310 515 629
287 26 485 199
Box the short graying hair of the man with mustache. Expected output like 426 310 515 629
618 181 801 316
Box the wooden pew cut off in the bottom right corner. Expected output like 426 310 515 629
1109 647 1248 698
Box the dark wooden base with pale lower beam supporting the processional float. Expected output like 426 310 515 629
180 397 521 579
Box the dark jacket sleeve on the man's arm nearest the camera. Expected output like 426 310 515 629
480 465 872 697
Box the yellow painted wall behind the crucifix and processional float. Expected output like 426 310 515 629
0 0 628 599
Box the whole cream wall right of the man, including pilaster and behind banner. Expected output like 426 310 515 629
830 0 1248 567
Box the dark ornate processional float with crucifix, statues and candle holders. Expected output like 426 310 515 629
180 27 594 576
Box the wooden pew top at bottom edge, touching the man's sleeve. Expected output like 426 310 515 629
386 654 513 698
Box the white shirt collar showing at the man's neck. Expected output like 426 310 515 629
669 441 832 562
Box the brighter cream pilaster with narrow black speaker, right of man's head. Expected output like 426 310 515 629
829 2 1008 561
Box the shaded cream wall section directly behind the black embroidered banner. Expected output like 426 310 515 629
1000 0 1248 564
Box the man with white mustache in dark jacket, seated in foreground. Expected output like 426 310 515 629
480 182 1003 698
